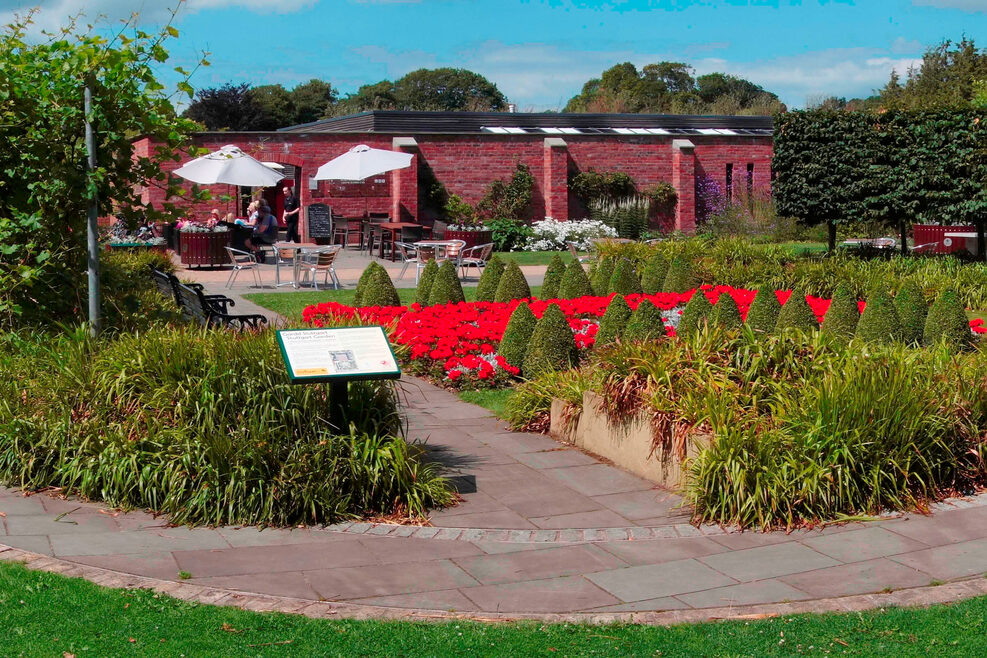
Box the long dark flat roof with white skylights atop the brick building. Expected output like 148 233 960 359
278 110 774 137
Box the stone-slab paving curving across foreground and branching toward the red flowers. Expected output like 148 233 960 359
0 254 987 622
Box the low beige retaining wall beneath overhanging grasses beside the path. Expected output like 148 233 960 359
550 391 708 489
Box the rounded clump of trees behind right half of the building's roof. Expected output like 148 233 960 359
564 62 785 115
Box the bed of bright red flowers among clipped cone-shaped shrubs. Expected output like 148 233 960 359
302 286 987 388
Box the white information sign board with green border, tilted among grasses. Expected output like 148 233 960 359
278 326 401 384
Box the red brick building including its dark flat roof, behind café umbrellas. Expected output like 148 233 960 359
138 111 773 235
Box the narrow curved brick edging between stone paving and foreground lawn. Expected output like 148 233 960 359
0 544 987 626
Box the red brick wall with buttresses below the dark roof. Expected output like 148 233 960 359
136 133 772 231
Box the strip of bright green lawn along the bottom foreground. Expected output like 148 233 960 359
0 564 987 658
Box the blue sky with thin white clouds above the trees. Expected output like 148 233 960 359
7 0 987 110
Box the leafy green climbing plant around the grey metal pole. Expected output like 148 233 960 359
0 12 199 326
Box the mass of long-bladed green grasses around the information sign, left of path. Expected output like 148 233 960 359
0 327 451 526
